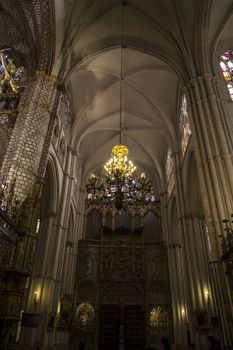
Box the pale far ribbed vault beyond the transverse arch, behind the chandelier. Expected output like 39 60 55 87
70 48 179 187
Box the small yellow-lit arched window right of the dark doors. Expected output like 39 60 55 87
149 305 168 335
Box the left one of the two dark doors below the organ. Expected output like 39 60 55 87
99 304 120 350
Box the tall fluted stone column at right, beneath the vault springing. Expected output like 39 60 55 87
188 74 233 260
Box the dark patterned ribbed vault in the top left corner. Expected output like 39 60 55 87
0 0 55 75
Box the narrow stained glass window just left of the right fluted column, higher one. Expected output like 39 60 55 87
179 95 191 156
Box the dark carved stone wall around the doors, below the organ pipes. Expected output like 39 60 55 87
73 228 171 344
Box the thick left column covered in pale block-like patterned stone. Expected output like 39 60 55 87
1 72 56 203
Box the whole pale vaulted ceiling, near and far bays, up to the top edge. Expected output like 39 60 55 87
54 0 232 187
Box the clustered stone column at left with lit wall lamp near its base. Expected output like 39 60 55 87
21 147 76 348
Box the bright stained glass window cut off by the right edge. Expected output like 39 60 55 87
220 48 233 101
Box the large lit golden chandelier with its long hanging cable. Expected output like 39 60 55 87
86 1 155 210
